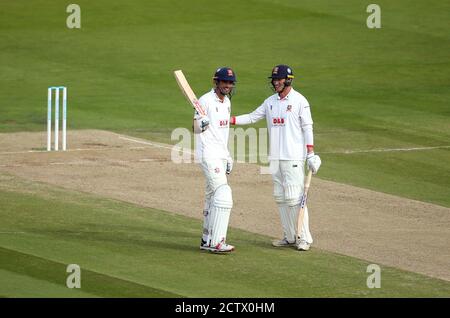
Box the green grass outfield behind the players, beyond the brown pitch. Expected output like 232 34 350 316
0 0 450 207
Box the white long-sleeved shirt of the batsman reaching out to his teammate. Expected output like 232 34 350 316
236 87 313 160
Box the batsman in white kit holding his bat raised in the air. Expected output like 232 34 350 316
193 67 236 253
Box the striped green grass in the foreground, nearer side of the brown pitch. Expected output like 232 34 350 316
0 183 450 297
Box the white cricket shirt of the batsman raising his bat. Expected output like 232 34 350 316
195 89 231 160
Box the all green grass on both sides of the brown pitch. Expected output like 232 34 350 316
0 0 450 297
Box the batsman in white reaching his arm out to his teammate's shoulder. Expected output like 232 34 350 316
231 65 321 251
